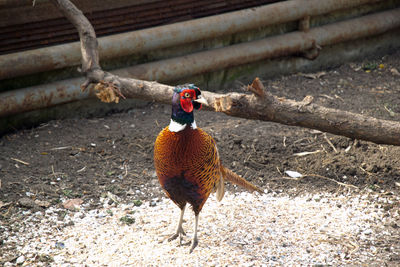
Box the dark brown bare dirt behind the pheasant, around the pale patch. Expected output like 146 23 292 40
0 52 400 264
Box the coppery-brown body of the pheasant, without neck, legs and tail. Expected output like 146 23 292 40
154 127 221 215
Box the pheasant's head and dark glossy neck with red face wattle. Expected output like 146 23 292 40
170 84 208 130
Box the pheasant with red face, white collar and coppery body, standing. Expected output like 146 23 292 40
154 84 263 253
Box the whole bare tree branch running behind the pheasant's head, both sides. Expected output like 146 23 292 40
52 0 400 145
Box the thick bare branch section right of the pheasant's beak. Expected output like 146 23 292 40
208 87 400 145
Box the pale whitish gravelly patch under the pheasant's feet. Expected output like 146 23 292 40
3 189 400 266
